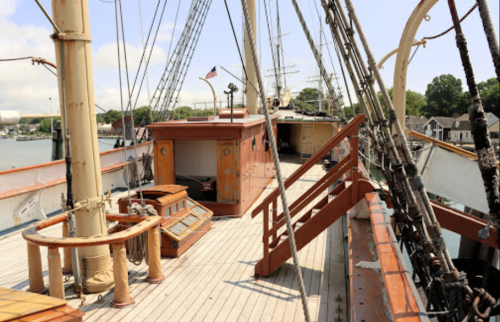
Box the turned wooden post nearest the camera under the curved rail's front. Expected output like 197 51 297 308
111 242 135 308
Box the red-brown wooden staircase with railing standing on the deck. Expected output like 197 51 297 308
252 115 374 276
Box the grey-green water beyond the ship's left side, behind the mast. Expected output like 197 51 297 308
0 139 123 171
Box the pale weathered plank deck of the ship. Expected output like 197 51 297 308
0 155 347 321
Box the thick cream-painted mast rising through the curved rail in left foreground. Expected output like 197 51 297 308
52 0 113 293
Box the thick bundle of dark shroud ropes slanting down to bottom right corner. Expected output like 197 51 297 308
304 0 498 321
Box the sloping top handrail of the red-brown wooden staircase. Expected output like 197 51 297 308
252 114 365 218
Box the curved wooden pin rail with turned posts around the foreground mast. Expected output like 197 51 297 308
22 213 165 307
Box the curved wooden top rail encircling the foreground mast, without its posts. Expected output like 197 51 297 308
22 213 161 248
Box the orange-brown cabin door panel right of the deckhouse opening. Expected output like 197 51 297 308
217 140 240 204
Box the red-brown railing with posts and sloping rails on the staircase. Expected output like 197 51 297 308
252 115 365 276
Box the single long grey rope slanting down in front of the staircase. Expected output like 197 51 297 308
241 0 311 322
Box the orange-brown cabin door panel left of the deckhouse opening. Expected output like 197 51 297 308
154 140 175 185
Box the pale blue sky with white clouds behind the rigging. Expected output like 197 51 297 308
0 0 500 113
